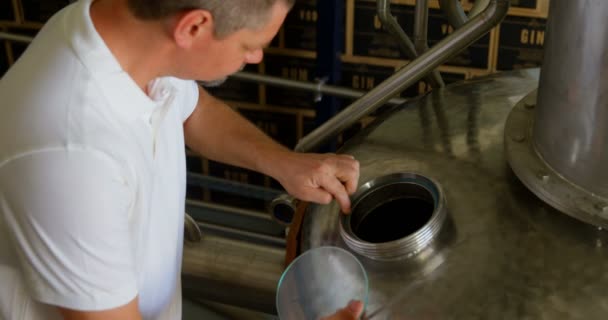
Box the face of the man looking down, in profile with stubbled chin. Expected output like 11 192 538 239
182 1 289 83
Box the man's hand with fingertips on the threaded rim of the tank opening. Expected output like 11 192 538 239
273 152 359 213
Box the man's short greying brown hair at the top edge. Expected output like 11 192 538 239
128 0 295 38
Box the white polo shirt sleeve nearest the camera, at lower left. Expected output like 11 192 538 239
0 150 137 311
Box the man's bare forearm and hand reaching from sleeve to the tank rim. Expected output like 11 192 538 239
184 88 359 212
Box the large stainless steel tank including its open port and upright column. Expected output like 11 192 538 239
301 0 608 319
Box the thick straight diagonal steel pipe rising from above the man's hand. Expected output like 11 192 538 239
295 0 509 152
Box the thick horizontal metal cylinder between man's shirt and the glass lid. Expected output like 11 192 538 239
182 234 285 314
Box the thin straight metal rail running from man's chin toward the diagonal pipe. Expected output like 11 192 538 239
230 71 407 105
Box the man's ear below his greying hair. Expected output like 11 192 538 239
173 9 214 49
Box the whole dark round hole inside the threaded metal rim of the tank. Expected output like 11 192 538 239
351 182 435 243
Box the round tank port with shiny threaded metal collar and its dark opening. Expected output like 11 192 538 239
340 172 447 260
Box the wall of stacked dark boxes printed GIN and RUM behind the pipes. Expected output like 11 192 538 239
0 0 549 210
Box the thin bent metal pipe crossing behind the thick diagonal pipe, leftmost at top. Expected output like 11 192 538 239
378 0 445 88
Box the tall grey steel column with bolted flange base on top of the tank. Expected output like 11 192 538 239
506 0 608 227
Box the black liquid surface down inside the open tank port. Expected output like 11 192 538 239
352 198 434 243
